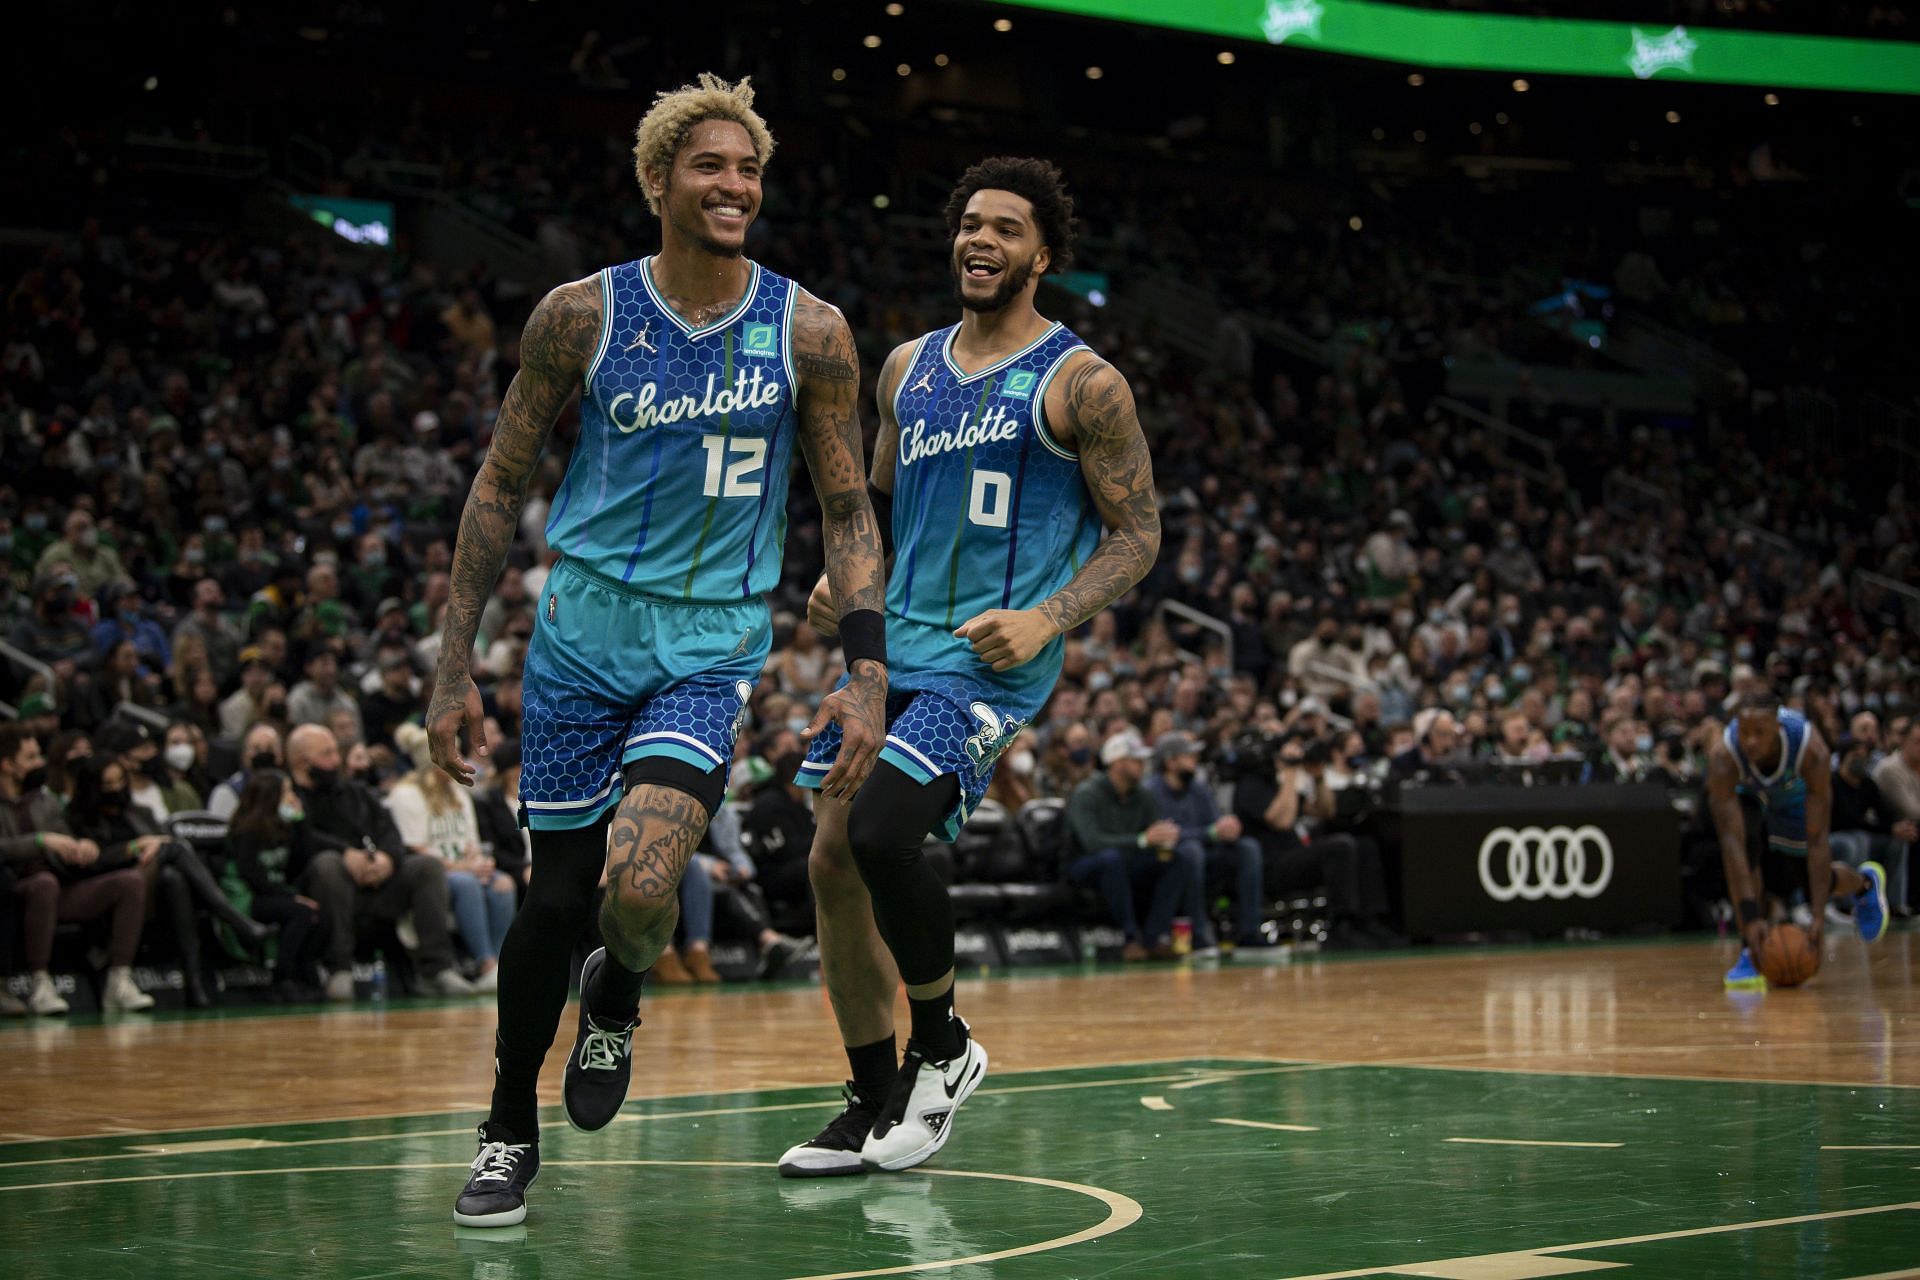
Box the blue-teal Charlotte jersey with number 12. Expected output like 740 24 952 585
547 257 799 603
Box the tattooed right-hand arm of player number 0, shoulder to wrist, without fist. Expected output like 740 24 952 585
1039 359 1160 633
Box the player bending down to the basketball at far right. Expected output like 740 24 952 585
1707 693 1887 988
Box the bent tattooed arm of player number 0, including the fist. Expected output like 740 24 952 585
954 353 1160 672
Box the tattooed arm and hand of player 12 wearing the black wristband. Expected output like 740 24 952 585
793 294 887 798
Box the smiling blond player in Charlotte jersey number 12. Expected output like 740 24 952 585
428 75 887 1226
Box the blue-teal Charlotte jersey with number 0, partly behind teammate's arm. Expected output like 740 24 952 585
887 314 1100 714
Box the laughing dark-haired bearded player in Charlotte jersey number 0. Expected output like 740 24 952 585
780 157 1160 1176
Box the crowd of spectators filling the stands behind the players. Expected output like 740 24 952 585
0 22 1920 1013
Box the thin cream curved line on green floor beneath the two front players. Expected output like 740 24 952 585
0 1159 1146 1280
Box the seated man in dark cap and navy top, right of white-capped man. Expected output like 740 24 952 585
1146 731 1267 950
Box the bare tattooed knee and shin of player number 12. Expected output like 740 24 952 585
599 785 707 973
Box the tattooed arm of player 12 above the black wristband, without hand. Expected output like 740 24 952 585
793 296 887 618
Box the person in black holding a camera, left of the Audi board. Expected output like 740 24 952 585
1233 735 1394 948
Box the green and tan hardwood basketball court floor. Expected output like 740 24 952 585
0 933 1920 1280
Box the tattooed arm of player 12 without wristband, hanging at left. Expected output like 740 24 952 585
426 278 601 787
